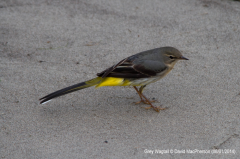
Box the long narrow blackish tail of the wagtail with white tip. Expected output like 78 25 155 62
39 77 102 104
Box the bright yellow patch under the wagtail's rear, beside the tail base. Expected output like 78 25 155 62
96 77 131 88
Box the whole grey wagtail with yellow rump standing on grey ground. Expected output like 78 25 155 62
40 47 188 112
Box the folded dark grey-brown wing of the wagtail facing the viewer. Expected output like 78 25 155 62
97 57 167 78
